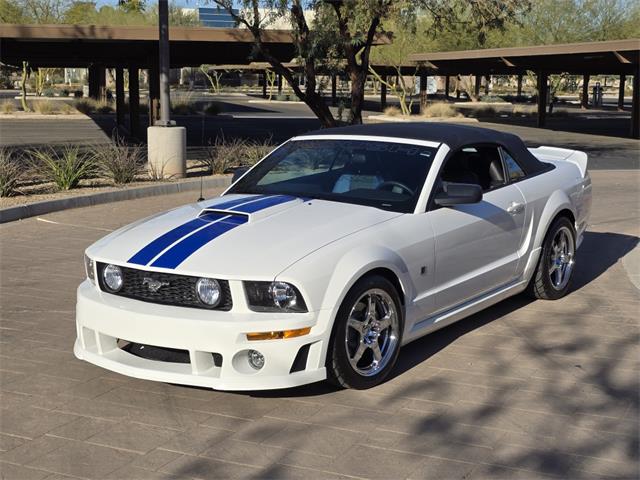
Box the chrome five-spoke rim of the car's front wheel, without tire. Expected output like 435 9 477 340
345 288 398 377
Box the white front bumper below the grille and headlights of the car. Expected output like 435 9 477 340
73 280 326 390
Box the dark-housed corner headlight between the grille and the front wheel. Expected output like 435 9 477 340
244 282 307 312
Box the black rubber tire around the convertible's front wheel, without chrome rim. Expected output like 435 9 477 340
326 275 404 390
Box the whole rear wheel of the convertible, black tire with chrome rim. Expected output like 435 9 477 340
527 217 576 300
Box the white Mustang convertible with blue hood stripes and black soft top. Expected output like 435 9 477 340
74 123 591 390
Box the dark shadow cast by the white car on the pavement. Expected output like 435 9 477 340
248 232 639 398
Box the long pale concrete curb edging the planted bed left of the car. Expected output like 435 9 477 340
0 175 231 223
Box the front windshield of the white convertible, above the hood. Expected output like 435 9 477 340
228 140 437 213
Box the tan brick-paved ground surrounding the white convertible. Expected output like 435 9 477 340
0 170 640 479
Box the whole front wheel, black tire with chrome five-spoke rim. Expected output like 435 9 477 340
327 275 403 390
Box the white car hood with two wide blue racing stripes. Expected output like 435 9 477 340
87 195 401 280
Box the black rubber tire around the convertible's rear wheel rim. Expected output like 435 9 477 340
526 216 576 300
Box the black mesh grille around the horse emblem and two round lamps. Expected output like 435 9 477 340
98 263 233 310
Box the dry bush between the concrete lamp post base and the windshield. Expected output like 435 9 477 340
202 135 273 173
